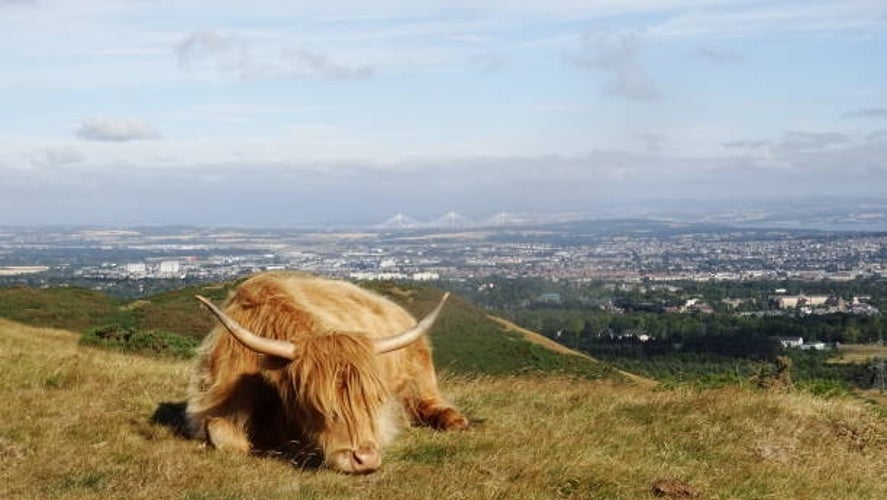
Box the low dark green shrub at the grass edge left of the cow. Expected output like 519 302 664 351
80 325 198 358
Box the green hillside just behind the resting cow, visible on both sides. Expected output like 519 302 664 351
0 283 621 378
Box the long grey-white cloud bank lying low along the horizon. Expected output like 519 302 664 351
0 126 887 225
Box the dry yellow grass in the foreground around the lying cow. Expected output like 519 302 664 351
0 320 887 499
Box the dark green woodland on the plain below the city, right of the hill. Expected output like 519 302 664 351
438 278 887 392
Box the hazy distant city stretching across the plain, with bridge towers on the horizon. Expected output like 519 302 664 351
0 213 887 288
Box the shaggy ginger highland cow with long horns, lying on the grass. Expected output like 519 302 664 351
186 273 468 473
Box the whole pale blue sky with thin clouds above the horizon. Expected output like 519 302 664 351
0 0 887 226
